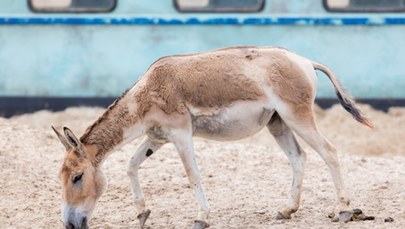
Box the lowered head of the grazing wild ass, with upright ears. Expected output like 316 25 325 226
52 127 106 229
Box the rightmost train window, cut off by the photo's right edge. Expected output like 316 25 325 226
323 0 405 12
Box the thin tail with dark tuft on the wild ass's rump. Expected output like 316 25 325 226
312 61 374 128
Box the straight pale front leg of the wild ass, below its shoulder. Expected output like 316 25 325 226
171 129 210 229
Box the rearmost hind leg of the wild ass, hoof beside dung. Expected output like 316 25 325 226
280 105 351 221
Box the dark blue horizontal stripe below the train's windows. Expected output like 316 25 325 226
0 17 405 25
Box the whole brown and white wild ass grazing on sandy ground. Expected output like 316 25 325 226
52 47 372 228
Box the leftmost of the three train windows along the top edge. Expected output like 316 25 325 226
28 0 116 13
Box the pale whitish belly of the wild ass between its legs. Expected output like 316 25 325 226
190 101 274 141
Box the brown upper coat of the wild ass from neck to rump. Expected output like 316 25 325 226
77 46 368 165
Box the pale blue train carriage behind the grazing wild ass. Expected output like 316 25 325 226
0 0 405 116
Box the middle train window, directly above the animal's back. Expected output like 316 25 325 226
173 0 264 13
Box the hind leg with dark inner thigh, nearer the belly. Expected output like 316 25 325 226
267 113 306 219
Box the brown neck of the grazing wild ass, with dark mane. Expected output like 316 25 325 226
80 95 141 164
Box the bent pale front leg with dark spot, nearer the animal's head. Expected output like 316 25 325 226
127 137 163 228
